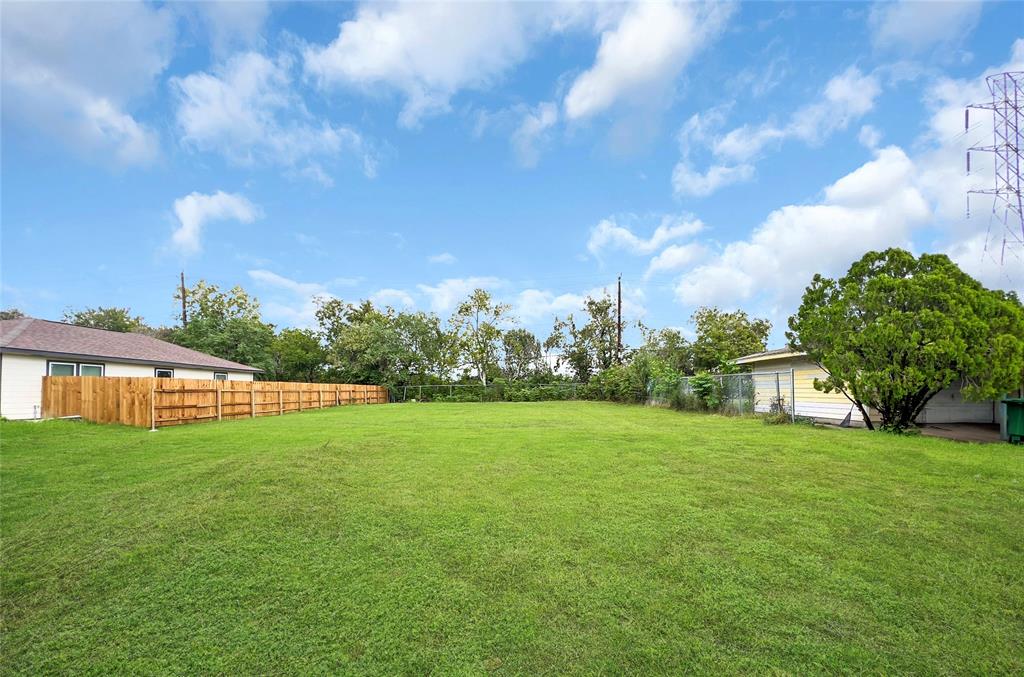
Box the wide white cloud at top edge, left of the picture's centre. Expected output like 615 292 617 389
304 2 580 127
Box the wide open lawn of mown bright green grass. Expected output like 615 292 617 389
6 403 1024 675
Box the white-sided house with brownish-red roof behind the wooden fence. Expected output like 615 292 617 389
0 318 260 419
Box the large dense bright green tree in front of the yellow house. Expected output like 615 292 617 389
786 249 1024 430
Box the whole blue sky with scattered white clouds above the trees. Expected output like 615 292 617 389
0 2 1024 343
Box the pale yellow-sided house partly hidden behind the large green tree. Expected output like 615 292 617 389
734 347 1006 436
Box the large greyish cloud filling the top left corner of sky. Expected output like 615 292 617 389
0 2 175 166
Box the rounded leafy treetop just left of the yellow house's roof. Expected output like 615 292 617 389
690 307 771 373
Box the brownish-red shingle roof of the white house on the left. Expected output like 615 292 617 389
0 318 263 372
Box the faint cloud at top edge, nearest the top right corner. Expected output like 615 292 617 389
868 0 982 52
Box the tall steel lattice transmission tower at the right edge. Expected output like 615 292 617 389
964 71 1024 268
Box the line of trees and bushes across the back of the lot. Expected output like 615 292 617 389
4 281 771 385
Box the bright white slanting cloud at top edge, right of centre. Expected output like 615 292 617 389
564 2 733 120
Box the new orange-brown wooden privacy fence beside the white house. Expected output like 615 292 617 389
43 376 388 428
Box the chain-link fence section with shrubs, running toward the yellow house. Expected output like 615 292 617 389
648 371 796 419
